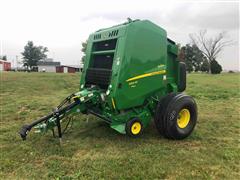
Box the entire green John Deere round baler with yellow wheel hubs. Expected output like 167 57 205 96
20 20 197 139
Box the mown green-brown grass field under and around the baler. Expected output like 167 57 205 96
0 73 240 179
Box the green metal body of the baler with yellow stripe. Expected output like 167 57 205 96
80 20 179 133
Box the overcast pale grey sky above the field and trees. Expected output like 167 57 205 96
0 0 240 70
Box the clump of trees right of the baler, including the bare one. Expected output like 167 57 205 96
178 30 232 74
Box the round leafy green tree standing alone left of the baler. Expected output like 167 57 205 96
21 41 48 69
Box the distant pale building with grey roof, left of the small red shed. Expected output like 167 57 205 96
37 61 61 72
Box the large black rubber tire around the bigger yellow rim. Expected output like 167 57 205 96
154 93 197 139
